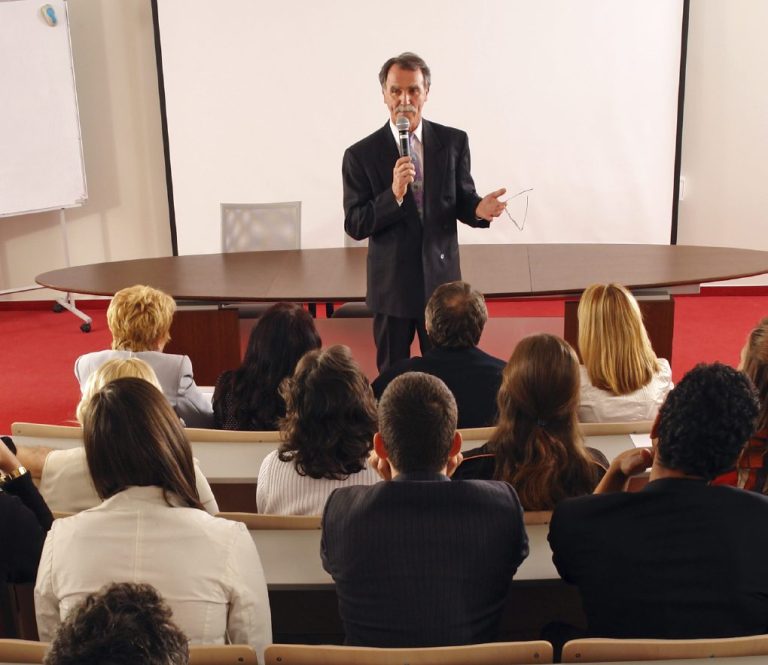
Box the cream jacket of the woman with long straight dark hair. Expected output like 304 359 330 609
35 487 272 662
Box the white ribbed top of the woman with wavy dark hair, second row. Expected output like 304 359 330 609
256 450 381 515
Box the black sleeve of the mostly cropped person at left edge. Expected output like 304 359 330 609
0 473 53 582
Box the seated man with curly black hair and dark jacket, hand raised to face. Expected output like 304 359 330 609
549 364 768 639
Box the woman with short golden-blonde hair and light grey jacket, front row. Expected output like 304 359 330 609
75 284 213 427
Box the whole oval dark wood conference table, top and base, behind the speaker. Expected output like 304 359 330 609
36 244 768 378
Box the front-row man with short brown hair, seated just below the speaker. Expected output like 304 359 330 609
373 282 504 428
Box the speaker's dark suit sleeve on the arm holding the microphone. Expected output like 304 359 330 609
341 144 406 240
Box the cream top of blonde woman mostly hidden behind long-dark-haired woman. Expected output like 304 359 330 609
38 446 219 515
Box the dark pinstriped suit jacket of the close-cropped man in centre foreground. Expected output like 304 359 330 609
321 474 528 647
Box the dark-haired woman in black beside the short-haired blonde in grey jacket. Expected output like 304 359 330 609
213 302 321 431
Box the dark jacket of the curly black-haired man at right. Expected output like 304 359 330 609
549 479 768 639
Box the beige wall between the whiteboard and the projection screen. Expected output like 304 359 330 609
0 0 171 299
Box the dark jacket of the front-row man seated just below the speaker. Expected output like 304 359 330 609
372 347 505 427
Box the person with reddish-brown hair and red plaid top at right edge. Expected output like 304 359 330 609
712 318 768 494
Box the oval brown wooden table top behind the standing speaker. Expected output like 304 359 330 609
36 244 768 302
